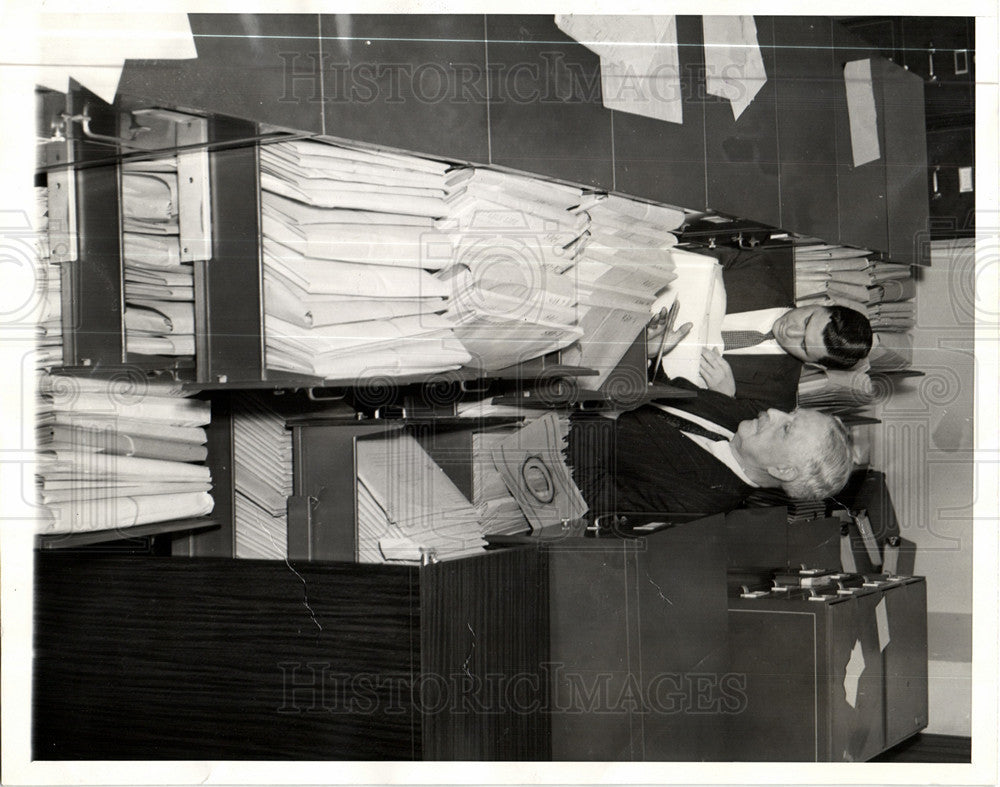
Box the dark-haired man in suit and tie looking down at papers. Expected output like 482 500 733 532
647 246 872 417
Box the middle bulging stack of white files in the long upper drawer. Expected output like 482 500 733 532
437 167 589 371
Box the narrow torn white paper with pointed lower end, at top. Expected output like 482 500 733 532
702 16 767 120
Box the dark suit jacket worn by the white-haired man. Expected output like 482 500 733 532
567 380 752 515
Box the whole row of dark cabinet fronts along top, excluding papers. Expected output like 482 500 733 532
119 14 927 260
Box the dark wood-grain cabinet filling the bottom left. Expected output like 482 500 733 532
33 548 549 760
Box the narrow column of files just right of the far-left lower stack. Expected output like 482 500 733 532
233 393 292 560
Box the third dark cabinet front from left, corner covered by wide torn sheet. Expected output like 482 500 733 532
486 14 614 189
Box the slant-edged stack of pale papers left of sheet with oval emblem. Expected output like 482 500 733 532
356 434 486 563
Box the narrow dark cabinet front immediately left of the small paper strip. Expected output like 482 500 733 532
774 16 838 238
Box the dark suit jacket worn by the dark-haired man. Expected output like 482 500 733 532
692 246 802 418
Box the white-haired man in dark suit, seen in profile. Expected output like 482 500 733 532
567 379 852 515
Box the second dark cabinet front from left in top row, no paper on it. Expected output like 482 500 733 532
320 14 489 163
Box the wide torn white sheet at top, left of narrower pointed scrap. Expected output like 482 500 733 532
555 14 683 123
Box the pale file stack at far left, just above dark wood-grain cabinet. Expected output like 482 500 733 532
37 375 213 533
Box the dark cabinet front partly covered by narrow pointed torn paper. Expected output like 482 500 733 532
705 16 781 226
